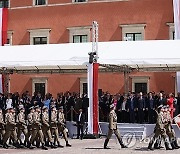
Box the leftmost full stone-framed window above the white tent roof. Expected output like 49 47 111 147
28 29 51 45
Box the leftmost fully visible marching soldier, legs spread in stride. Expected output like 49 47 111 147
3 108 20 149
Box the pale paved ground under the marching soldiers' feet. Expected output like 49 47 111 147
0 138 180 154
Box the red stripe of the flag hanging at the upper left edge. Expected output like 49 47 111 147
2 8 8 45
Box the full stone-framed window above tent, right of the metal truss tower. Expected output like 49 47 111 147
120 24 146 41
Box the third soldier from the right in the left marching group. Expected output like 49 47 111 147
42 106 57 148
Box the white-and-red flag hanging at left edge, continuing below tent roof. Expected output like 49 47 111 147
0 8 8 93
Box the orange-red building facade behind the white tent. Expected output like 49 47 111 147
0 0 176 96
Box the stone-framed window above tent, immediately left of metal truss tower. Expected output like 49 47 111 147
68 26 92 43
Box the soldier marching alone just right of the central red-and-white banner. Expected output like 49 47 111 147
104 104 127 149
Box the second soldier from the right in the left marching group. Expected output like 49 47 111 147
50 106 63 148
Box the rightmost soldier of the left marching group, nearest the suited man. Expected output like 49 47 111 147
58 106 71 147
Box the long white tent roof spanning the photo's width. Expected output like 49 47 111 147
0 40 180 70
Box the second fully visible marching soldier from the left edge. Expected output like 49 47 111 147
17 107 29 146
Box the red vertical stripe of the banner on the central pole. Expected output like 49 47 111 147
93 63 99 135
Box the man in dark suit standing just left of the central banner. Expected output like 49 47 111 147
77 109 85 140
